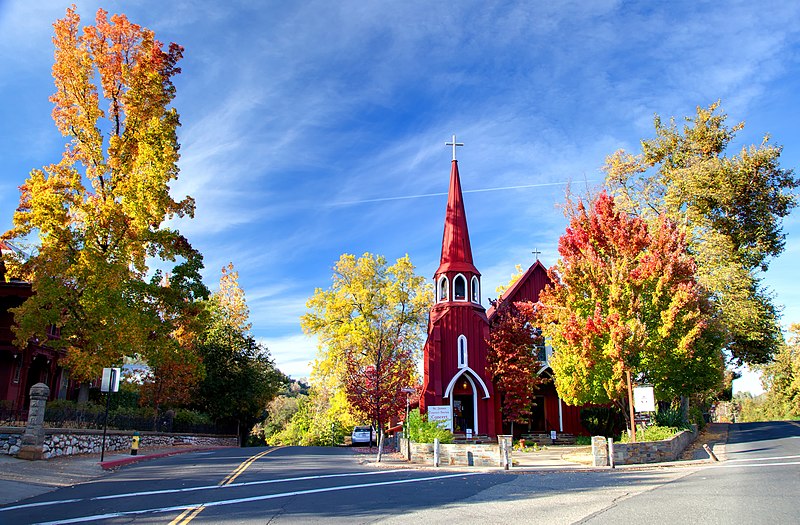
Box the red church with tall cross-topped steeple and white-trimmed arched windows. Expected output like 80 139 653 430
420 137 586 439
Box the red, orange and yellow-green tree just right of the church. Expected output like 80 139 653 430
536 192 723 422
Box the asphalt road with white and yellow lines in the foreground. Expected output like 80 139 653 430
0 422 800 524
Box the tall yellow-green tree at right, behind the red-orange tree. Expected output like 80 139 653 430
605 102 800 364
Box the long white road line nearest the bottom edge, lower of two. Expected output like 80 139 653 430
37 472 482 525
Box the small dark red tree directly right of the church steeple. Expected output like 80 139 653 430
486 299 544 434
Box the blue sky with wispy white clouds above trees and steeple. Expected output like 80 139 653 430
0 0 800 392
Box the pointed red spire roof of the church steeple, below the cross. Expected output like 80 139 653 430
436 159 480 275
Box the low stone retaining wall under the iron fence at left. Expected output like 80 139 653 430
0 427 238 459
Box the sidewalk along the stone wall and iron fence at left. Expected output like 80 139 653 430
0 446 230 505
